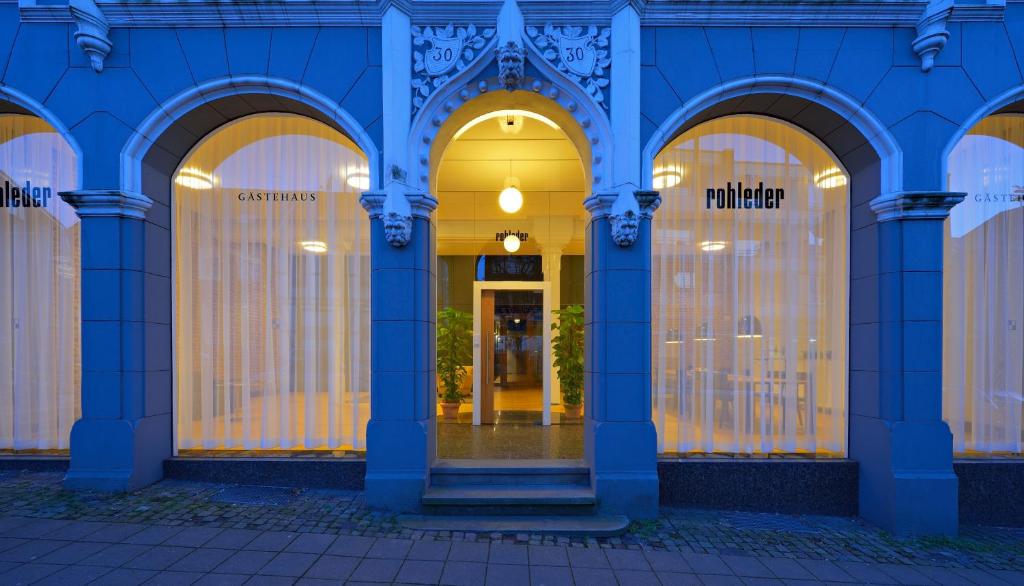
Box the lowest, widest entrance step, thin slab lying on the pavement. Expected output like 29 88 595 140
398 515 630 537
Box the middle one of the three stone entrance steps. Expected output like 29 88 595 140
423 485 597 507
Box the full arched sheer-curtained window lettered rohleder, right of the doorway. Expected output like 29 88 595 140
651 116 849 455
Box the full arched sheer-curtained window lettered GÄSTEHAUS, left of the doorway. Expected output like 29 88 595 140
174 114 370 450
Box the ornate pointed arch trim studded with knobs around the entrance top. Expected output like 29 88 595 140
408 38 614 193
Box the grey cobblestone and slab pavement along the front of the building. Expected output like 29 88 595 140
0 472 1024 586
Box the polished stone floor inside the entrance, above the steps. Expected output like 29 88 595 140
437 411 583 460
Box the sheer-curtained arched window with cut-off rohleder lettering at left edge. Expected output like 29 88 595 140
0 114 81 450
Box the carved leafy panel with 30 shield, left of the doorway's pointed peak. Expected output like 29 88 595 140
412 25 495 114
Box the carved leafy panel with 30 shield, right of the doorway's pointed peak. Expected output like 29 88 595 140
526 25 611 110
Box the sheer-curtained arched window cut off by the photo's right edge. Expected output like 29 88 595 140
942 115 1024 454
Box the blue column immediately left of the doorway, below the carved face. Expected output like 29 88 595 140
362 189 437 511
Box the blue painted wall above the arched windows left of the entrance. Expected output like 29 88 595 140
0 3 382 189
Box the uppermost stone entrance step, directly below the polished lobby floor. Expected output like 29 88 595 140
430 460 590 487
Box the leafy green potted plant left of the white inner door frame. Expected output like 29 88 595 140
437 307 473 419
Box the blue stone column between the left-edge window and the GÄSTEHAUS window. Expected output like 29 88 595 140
60 190 172 491
